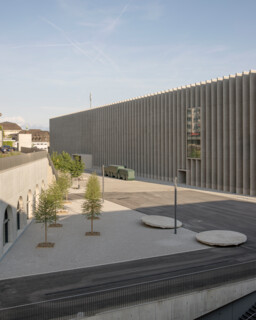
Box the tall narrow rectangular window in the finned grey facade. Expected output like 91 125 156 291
187 107 201 159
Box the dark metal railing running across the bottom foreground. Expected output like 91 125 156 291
0 261 256 320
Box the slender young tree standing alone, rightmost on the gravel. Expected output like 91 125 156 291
82 173 102 235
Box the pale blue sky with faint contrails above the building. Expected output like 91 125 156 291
0 0 256 129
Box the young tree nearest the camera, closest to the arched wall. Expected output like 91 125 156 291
35 190 55 247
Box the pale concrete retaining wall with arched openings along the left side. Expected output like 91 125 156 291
0 151 53 258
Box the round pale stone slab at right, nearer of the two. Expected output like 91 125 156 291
196 230 247 247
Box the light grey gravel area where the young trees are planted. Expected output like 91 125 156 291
0 184 208 279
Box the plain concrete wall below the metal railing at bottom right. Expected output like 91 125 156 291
80 279 256 320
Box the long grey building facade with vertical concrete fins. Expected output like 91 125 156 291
50 71 256 196
